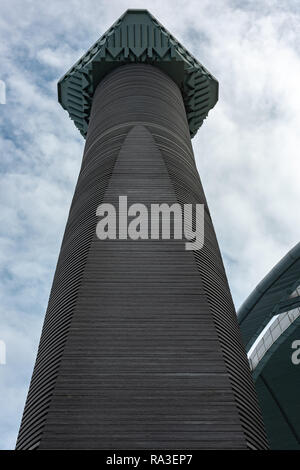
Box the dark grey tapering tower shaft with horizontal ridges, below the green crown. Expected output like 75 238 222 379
17 11 267 449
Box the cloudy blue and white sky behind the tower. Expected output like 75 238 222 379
0 0 300 449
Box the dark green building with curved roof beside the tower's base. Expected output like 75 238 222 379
238 243 300 450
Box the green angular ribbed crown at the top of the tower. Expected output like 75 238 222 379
58 10 218 137
